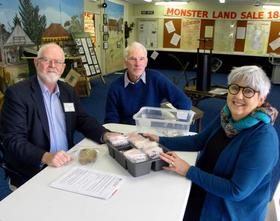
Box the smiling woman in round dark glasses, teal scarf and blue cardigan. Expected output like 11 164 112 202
145 66 279 221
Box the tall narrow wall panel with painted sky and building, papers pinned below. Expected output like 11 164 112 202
103 1 124 73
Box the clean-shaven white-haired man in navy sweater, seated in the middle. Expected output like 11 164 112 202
105 42 192 124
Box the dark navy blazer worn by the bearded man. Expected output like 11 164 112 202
1 76 106 178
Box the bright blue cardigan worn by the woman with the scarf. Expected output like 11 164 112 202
160 117 279 221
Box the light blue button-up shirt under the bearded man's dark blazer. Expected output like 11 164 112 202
38 78 68 153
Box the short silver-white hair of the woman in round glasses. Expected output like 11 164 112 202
228 65 271 97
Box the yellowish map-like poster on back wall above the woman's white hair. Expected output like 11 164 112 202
244 21 270 55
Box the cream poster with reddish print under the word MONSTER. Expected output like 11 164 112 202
181 19 200 50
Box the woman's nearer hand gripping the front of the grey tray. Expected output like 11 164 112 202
160 152 190 176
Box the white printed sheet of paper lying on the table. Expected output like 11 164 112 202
50 167 124 199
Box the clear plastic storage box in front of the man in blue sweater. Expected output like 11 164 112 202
133 107 195 136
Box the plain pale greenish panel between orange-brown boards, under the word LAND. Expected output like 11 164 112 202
214 20 236 52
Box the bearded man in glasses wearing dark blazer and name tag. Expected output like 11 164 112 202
1 43 111 185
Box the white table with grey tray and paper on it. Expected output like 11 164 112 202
0 124 197 221
